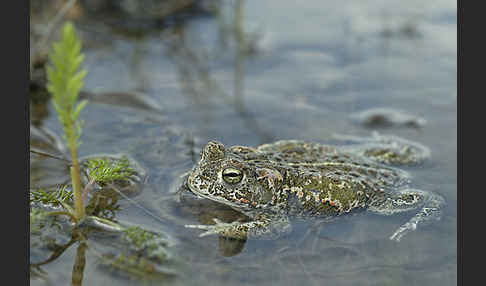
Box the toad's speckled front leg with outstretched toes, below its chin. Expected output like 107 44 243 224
185 214 291 239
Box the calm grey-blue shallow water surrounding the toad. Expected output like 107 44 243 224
31 0 457 286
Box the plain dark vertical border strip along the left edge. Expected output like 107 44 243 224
8 0 31 285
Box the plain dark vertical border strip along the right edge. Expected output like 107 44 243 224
457 1 478 285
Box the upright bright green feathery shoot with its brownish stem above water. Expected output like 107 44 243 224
47 22 87 222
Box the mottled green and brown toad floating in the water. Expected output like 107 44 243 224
186 134 444 241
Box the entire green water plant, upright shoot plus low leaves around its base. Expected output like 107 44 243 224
30 22 175 284
